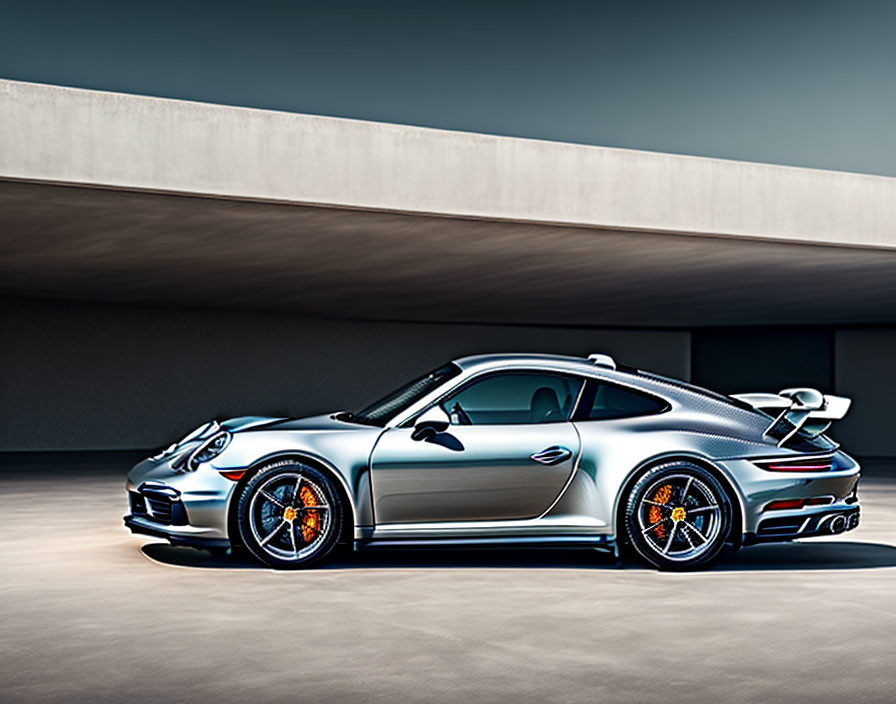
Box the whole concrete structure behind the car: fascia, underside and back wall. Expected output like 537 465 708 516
0 80 896 456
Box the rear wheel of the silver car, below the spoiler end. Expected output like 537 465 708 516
625 461 732 570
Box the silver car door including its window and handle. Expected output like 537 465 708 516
371 371 582 525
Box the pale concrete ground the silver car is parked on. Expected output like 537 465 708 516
0 464 896 703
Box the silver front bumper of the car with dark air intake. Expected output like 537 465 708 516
124 458 242 547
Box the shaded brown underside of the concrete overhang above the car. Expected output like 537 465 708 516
0 180 896 326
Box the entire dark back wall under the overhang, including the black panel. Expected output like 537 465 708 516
0 298 896 458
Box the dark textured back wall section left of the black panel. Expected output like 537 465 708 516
0 299 690 451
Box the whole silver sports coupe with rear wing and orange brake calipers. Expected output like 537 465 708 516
125 354 859 569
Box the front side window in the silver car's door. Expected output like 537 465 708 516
441 372 582 425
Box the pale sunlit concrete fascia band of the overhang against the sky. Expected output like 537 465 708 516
0 80 896 247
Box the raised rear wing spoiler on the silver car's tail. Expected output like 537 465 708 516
732 388 852 447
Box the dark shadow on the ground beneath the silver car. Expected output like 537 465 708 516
141 540 896 572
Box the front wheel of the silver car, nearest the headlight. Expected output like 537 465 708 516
237 460 342 569
